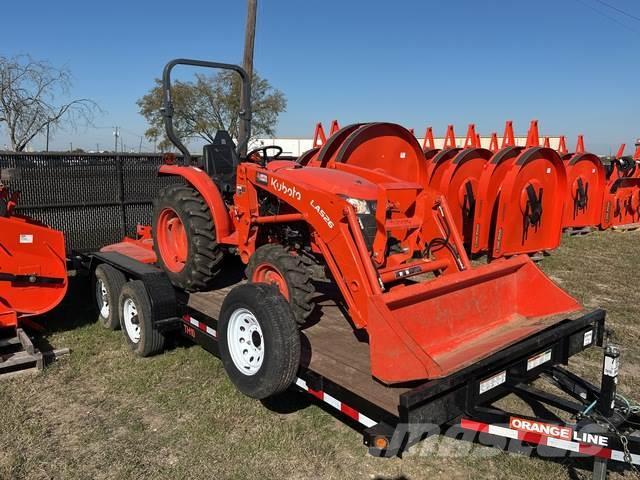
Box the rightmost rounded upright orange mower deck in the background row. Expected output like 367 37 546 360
562 153 607 228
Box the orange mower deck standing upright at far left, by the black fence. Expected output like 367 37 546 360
0 215 67 327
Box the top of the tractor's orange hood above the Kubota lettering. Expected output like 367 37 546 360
267 162 378 200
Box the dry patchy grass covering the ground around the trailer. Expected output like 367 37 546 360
0 232 640 480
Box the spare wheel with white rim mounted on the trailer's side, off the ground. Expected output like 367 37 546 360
218 283 300 399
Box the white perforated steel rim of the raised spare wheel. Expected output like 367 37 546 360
227 308 264 376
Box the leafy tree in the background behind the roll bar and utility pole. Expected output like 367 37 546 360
137 72 287 151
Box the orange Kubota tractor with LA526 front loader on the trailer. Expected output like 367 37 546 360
103 59 592 384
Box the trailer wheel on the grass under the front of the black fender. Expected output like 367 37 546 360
118 280 165 357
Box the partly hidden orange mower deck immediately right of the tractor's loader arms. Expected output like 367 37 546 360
430 148 493 247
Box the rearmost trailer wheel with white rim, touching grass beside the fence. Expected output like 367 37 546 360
93 263 127 330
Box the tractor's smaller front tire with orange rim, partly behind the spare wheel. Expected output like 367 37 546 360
245 243 316 325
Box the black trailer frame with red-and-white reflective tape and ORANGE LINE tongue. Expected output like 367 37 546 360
88 252 640 479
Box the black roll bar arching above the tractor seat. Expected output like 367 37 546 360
161 58 251 164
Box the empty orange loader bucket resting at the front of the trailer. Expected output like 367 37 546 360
367 255 582 384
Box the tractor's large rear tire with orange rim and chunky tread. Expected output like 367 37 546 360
152 185 224 292
